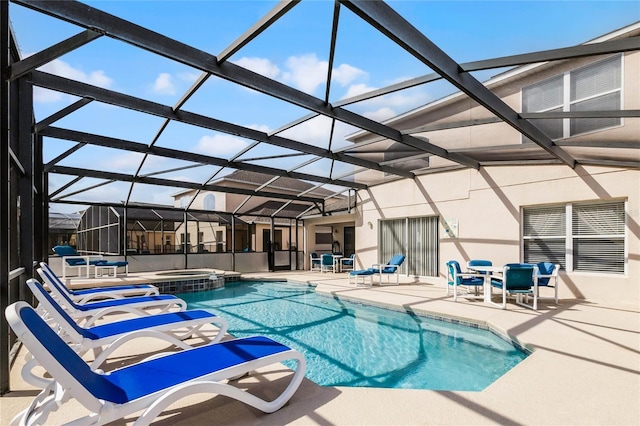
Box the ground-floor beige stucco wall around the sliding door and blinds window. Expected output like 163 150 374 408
356 166 640 307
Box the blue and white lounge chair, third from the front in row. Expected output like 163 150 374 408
38 268 187 326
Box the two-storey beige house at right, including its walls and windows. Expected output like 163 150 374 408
350 23 640 307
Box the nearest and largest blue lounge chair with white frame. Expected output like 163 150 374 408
5 302 306 425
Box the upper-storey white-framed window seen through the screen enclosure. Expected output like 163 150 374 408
522 55 622 141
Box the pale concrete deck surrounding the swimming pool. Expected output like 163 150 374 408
0 271 640 425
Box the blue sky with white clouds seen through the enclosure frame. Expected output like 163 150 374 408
10 0 640 212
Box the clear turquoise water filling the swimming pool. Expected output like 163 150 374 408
179 281 526 391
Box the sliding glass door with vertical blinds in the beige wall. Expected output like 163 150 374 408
378 216 439 276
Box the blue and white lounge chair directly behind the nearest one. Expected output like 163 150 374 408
22 279 228 388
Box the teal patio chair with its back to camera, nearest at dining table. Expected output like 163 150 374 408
489 263 538 311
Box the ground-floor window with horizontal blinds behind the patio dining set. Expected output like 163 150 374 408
522 201 626 274
